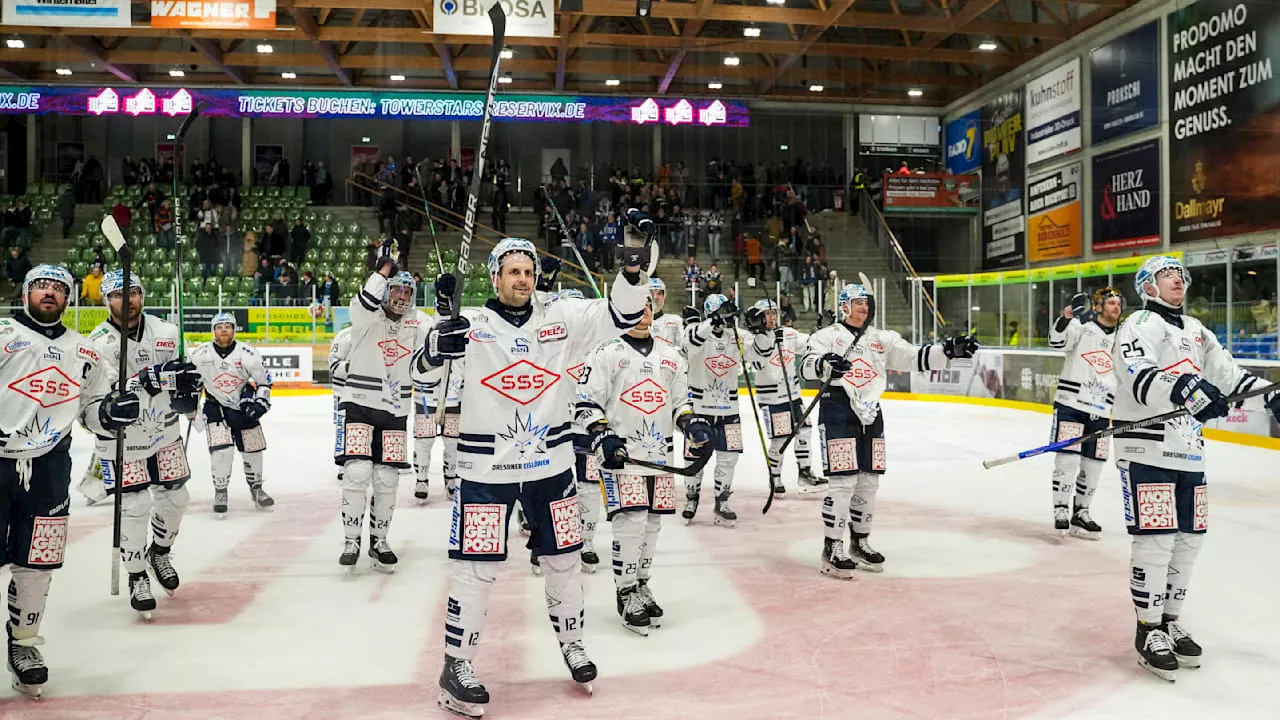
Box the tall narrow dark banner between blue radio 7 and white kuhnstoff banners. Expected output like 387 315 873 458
982 90 1027 270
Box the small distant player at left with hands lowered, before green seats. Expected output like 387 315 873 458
188 313 275 518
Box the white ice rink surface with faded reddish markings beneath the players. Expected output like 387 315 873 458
0 396 1280 720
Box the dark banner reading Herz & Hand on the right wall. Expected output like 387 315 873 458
1091 138 1161 252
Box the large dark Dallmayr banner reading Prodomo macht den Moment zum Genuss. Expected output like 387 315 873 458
1166 0 1280 242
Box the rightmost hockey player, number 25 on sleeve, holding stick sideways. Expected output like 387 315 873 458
1114 255 1280 682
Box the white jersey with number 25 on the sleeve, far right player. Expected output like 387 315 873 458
1112 307 1265 473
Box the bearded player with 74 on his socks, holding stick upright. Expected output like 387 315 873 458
83 270 200 619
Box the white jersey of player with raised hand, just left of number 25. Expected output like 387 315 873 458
1048 318 1117 418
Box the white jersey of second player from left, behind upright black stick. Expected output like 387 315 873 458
84 314 182 461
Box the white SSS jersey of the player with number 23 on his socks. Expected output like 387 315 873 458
576 337 694 475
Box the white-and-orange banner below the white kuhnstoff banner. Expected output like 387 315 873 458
1027 163 1084 263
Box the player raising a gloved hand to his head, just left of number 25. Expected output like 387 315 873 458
1048 287 1124 539
